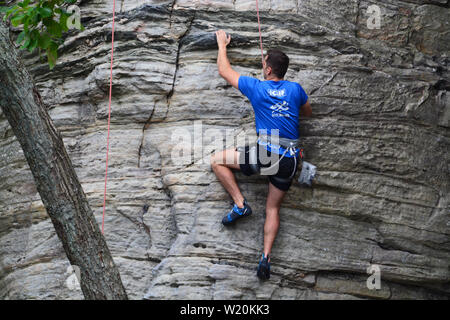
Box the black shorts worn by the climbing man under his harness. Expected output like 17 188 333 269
236 144 299 191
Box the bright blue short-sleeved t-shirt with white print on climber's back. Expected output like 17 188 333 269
238 76 308 153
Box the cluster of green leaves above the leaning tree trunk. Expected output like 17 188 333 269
0 0 84 69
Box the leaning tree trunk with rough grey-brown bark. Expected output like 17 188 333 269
0 22 127 299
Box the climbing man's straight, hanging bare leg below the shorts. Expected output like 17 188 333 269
264 182 286 260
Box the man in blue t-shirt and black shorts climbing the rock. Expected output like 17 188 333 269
211 30 312 279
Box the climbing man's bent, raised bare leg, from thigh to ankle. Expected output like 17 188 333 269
211 149 244 208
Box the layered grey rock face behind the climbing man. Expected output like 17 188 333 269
0 0 450 299
